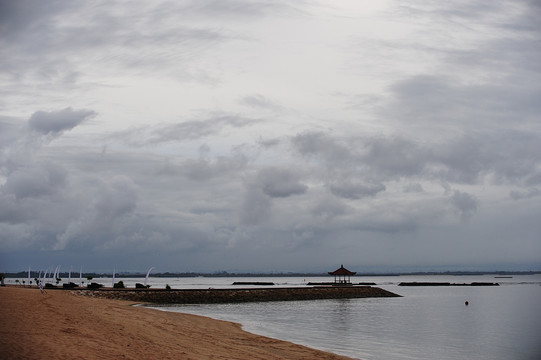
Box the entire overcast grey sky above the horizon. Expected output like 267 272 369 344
0 0 541 272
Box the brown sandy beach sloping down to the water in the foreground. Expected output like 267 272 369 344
0 286 348 359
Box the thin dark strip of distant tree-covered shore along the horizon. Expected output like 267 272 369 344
4 270 541 279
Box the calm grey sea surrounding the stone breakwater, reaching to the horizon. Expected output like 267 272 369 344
11 274 541 360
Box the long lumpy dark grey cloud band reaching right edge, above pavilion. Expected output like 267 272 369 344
291 130 541 190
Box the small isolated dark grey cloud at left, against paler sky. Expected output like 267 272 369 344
28 108 96 134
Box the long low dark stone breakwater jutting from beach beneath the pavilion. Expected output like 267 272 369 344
72 286 400 304
